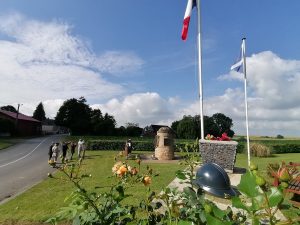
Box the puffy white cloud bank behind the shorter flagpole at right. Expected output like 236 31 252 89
214 51 300 136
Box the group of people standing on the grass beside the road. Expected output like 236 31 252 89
48 139 85 162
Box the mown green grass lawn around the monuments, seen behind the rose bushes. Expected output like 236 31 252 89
0 151 300 225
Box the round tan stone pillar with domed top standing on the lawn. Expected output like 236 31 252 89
155 127 175 160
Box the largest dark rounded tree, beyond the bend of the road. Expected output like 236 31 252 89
55 97 92 135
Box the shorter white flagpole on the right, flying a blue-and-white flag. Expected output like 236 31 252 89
242 38 250 167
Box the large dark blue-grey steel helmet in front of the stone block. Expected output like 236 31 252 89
194 163 237 198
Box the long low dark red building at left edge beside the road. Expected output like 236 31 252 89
0 109 42 136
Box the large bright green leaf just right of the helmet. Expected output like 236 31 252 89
238 171 259 197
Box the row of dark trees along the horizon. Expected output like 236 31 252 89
0 97 234 139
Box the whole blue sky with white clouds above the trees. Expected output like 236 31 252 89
0 0 300 137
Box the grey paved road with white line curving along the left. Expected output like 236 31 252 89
0 135 62 204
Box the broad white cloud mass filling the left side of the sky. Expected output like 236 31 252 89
0 13 143 115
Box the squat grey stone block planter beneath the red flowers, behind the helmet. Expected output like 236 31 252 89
199 140 238 173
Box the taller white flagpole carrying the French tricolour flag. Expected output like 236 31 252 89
197 0 204 140
